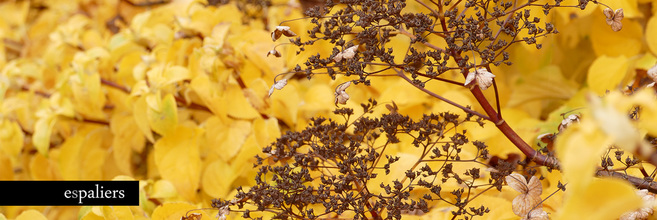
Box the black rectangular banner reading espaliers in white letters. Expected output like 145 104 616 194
0 181 139 206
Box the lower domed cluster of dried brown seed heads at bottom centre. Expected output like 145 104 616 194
213 100 515 219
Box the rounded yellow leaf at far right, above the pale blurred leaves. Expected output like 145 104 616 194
586 55 628 95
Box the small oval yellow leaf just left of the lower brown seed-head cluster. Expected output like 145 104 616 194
203 160 237 198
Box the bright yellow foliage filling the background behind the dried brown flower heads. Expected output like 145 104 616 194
0 0 657 220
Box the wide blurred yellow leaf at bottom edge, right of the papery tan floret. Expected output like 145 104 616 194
557 178 642 219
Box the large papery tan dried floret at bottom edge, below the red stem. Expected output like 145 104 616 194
505 173 543 217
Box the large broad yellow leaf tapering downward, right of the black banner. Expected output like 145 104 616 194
154 126 203 201
